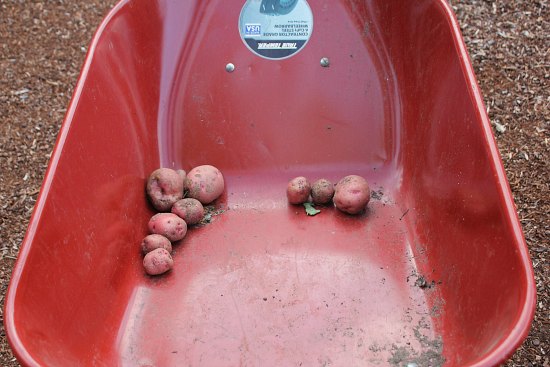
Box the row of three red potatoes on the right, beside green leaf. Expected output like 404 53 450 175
286 175 370 214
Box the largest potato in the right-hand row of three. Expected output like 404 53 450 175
333 175 370 214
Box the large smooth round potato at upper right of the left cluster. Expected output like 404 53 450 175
185 165 224 205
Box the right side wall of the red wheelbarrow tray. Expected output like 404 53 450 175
369 0 535 366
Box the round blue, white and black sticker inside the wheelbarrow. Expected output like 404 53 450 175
239 0 313 60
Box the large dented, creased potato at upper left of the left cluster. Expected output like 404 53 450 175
147 168 183 212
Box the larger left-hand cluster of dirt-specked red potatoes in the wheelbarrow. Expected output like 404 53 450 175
141 165 224 275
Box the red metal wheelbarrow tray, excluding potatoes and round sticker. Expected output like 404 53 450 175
5 0 535 366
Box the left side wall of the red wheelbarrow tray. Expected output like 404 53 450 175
6 2 166 366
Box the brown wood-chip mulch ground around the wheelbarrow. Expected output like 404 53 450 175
0 0 550 367
